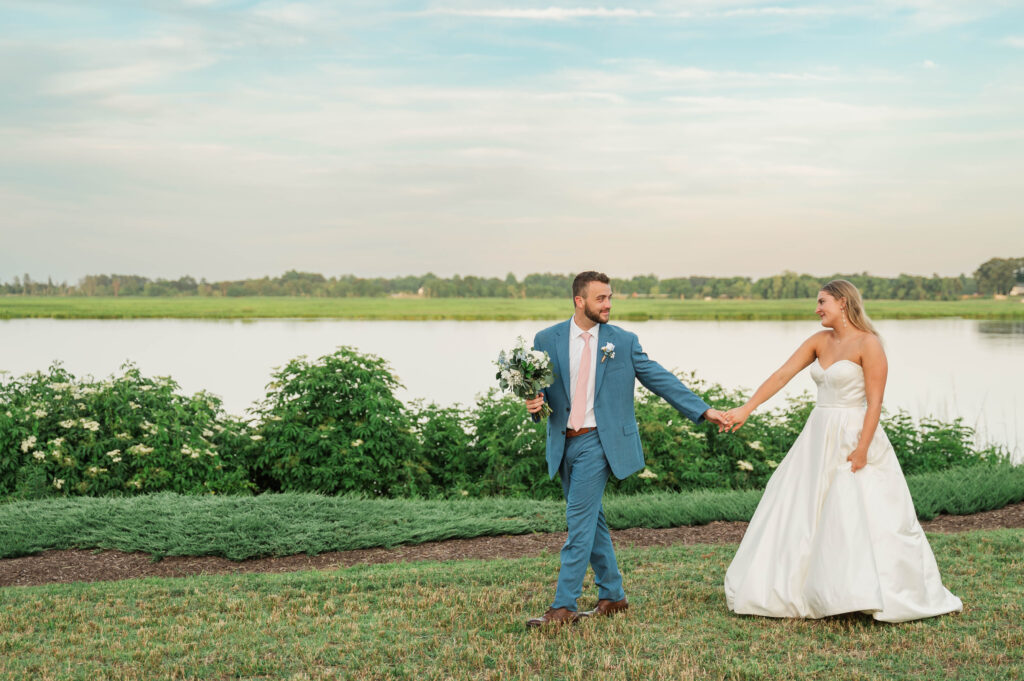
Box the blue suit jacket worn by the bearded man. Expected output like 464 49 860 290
534 320 710 479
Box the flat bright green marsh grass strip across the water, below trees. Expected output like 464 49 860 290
0 296 1024 321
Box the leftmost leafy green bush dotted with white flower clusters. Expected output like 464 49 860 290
0 364 254 498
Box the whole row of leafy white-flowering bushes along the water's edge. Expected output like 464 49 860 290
0 347 1006 499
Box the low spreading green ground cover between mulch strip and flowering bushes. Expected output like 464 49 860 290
0 464 1024 560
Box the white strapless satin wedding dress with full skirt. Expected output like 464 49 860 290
725 359 964 622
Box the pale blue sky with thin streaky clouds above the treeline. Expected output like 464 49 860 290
0 0 1024 283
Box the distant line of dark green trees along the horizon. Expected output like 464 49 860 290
0 258 1024 300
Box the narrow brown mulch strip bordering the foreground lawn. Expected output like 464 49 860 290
0 503 1024 587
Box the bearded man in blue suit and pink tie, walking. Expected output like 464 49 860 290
526 271 726 627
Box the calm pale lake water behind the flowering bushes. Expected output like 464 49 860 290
0 320 1024 460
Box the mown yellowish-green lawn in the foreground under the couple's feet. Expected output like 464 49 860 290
0 529 1024 681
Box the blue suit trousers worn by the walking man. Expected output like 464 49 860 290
551 430 626 611
